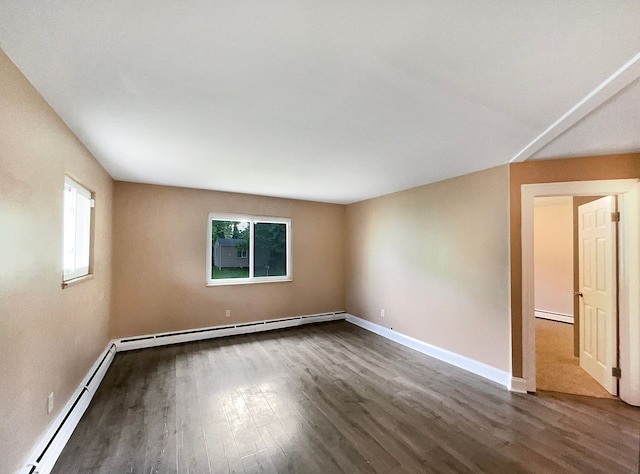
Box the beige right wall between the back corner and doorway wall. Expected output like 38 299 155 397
347 166 510 371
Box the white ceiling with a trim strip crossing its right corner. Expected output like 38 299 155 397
0 0 640 203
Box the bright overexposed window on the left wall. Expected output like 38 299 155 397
62 176 93 282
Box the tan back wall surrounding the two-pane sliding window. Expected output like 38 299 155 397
112 182 345 337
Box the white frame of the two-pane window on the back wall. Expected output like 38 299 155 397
207 213 293 286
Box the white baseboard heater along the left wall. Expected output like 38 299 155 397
19 341 116 474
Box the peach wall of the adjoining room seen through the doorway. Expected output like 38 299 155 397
533 196 573 316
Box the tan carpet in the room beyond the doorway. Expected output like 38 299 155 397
536 319 615 398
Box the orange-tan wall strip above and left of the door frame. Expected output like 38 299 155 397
509 153 640 377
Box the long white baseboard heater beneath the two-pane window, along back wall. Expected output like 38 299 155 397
115 311 347 352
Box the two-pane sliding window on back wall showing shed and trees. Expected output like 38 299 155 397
207 214 291 285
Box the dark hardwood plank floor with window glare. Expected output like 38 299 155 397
54 322 640 474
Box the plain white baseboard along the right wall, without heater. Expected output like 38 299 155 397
347 314 512 390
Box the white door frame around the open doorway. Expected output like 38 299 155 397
520 179 640 406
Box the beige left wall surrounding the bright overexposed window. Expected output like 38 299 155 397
0 50 113 472
